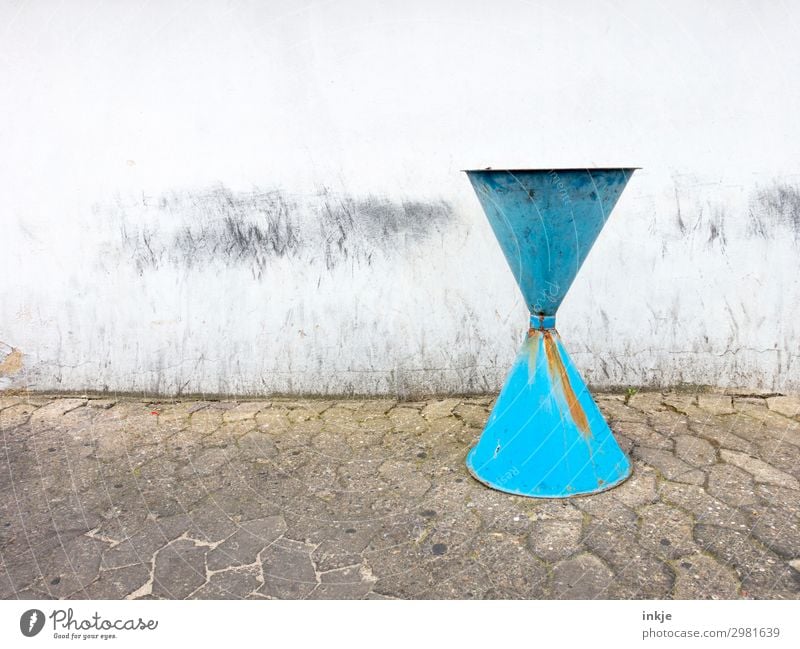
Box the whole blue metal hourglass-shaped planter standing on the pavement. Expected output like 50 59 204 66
467 168 634 498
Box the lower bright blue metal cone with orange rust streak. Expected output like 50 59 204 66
467 318 631 498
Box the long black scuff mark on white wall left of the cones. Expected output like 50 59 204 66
108 187 453 277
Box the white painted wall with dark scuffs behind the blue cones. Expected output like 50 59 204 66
0 0 800 394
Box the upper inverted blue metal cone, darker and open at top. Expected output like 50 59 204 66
466 168 635 316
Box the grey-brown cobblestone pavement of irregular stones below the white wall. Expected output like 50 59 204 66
0 392 800 599
